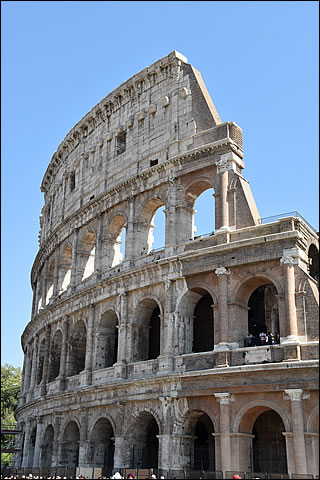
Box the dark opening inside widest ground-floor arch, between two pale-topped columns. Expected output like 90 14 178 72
252 410 287 473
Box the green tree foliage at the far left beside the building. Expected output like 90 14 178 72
1 363 22 424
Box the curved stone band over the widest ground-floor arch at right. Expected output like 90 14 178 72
231 400 291 433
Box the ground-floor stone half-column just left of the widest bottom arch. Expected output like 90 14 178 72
214 393 233 472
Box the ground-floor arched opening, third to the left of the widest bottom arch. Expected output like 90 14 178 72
90 418 114 475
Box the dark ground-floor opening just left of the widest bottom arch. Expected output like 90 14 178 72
192 413 215 471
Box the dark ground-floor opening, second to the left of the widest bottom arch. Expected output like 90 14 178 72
130 412 159 468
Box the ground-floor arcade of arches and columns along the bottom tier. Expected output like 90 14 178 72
22 398 319 475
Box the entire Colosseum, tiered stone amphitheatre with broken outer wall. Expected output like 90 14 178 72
16 51 319 478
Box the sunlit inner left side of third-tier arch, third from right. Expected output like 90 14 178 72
101 210 128 269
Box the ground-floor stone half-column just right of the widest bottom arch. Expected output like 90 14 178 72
284 388 309 474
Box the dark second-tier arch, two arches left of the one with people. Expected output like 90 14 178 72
133 296 163 361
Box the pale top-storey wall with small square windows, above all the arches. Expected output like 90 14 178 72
40 52 225 243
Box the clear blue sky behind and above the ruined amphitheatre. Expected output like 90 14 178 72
1 1 319 366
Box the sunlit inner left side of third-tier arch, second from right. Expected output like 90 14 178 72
135 194 165 255
